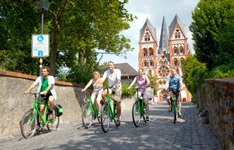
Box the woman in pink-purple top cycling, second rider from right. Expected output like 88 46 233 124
128 69 152 121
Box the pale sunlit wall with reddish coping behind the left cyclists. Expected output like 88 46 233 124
0 70 134 138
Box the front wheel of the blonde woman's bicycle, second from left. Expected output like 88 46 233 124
82 103 94 129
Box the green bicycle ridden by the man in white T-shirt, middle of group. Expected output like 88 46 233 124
101 88 119 133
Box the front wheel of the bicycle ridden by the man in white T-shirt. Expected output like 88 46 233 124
101 104 111 133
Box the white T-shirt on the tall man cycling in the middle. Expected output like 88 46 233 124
102 69 122 88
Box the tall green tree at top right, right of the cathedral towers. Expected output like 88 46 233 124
189 0 232 70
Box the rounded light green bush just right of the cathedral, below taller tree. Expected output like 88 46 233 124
182 55 207 95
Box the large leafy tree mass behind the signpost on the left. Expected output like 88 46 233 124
0 0 134 78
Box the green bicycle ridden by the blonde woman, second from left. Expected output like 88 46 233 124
82 96 100 129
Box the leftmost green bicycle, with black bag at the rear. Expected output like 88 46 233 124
20 93 59 139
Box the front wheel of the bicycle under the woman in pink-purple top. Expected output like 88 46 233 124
132 101 141 127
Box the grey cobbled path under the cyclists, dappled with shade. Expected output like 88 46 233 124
0 103 220 150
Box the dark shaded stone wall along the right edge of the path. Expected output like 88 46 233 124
198 79 234 149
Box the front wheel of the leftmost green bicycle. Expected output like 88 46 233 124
20 109 37 139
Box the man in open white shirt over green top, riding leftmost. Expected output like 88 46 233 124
24 66 57 126
